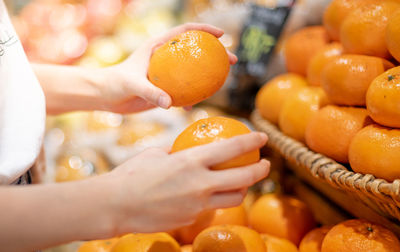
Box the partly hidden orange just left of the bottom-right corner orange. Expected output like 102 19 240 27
299 226 332 252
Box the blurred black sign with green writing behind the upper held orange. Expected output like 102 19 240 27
229 0 294 111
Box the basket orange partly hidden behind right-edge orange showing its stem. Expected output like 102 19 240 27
322 55 393 106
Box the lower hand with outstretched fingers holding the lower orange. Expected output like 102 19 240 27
105 132 269 234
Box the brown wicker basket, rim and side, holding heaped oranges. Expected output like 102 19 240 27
251 111 400 223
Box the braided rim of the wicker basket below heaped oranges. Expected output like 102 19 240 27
250 109 400 206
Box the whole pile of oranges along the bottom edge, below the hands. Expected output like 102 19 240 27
78 194 400 252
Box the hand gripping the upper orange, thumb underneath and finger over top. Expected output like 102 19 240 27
102 23 237 113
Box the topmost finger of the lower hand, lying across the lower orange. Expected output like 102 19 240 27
181 132 268 166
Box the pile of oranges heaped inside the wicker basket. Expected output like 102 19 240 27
256 0 400 181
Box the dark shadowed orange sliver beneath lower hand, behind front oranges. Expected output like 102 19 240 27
176 210 215 244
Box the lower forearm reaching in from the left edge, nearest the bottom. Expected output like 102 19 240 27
0 176 115 251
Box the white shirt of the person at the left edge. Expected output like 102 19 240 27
0 0 46 185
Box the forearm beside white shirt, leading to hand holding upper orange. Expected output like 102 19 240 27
32 64 111 114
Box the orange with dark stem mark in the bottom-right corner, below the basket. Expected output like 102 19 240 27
321 220 400 252
